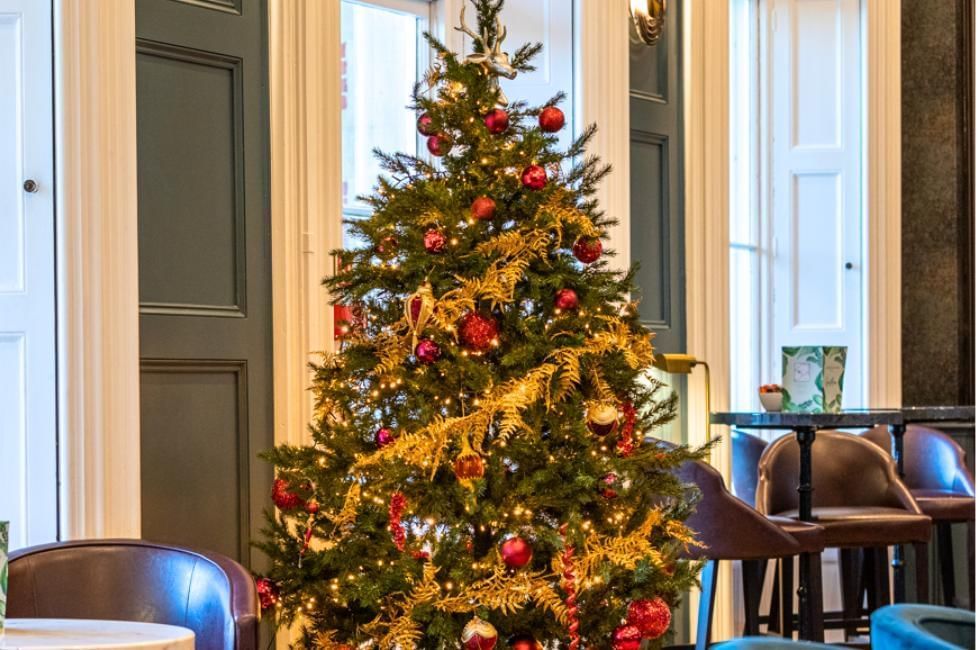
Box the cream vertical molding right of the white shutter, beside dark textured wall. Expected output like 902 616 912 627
865 0 902 407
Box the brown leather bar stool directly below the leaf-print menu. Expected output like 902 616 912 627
756 431 931 633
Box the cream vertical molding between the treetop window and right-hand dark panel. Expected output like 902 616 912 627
576 0 630 270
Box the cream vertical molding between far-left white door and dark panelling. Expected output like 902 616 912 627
54 0 140 539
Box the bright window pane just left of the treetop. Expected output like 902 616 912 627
341 0 425 246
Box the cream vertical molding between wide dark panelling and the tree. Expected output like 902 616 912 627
269 0 342 444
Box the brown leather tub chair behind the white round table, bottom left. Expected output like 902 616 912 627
7 539 259 650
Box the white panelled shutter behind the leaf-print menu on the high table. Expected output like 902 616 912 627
769 0 866 408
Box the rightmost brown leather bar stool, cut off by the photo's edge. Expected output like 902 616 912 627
861 425 976 609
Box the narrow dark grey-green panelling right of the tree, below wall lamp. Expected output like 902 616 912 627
630 2 685 352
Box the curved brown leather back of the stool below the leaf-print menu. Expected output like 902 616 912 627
756 430 920 514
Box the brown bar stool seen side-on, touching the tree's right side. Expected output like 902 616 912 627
677 461 823 650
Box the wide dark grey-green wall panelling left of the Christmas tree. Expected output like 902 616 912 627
136 0 273 565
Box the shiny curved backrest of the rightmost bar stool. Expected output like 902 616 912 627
861 424 976 497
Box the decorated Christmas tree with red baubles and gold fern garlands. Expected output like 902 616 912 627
259 0 698 650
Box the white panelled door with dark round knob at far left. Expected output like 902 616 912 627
0 0 58 548
